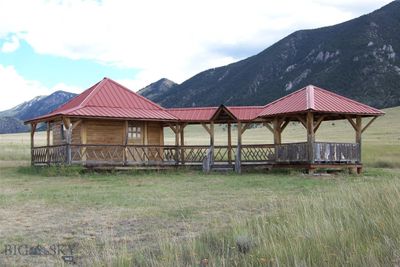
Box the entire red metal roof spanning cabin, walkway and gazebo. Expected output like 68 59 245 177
27 78 384 125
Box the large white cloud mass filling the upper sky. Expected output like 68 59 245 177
0 0 390 91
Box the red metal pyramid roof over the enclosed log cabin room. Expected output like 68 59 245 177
30 78 177 121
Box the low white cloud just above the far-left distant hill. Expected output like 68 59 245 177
0 64 82 111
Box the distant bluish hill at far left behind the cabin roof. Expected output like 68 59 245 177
0 91 76 134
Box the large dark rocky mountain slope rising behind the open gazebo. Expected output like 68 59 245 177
149 1 400 108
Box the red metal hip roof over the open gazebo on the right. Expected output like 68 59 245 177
258 85 384 117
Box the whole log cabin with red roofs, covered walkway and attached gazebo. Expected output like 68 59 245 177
25 78 384 173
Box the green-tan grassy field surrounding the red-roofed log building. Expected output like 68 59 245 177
0 108 400 266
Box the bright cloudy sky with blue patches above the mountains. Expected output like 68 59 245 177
0 0 391 110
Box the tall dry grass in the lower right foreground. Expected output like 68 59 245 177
83 180 400 266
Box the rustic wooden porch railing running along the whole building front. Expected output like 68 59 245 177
32 142 360 165
